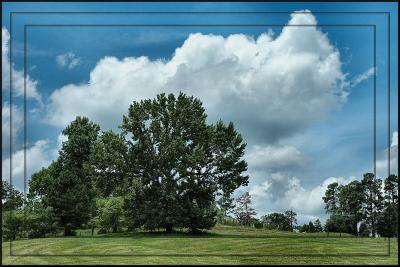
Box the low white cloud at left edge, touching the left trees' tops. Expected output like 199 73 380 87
2 140 54 193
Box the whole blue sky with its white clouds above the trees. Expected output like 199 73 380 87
2 3 398 223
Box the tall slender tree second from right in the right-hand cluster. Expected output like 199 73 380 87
361 173 383 239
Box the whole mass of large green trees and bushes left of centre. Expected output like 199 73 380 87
2 93 248 239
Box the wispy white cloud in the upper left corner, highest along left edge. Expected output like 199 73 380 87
1 27 42 103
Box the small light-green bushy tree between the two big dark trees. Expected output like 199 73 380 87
95 197 124 233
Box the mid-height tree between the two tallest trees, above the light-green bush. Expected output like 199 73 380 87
89 131 128 197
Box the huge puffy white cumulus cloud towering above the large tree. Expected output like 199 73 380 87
46 13 348 143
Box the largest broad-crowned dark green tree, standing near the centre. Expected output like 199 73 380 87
121 93 248 232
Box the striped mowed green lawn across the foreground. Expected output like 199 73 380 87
2 226 398 264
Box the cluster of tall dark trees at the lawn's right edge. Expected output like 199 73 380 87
323 173 399 237
